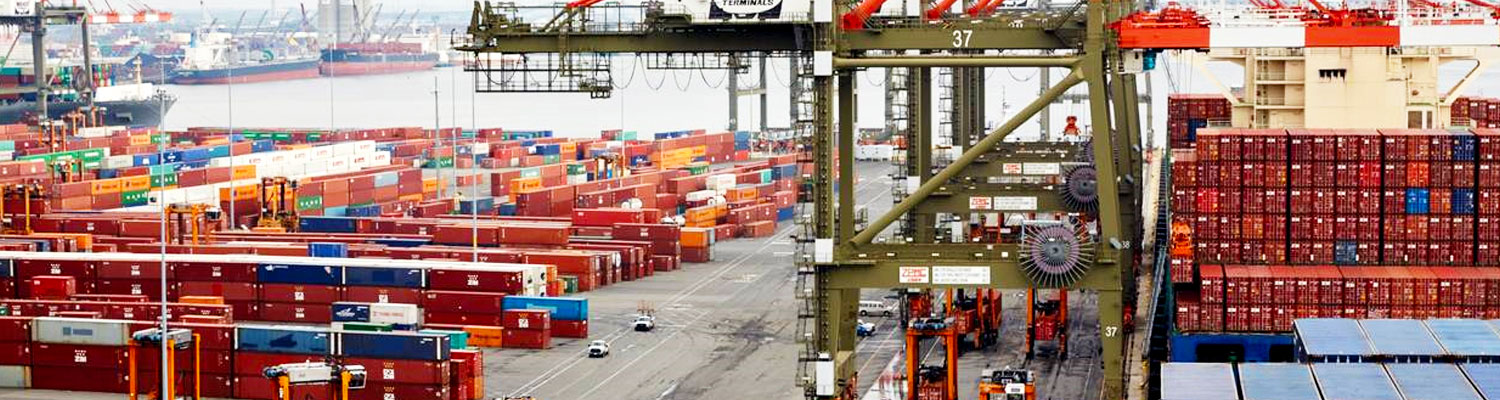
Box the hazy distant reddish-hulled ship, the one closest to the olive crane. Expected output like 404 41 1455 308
320 42 440 76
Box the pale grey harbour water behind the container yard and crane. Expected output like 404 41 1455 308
155 57 1500 138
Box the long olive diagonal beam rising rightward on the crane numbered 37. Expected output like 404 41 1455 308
849 69 1080 244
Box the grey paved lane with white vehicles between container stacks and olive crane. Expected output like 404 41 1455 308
485 162 894 400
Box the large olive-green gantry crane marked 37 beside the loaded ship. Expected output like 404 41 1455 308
459 0 1149 399
